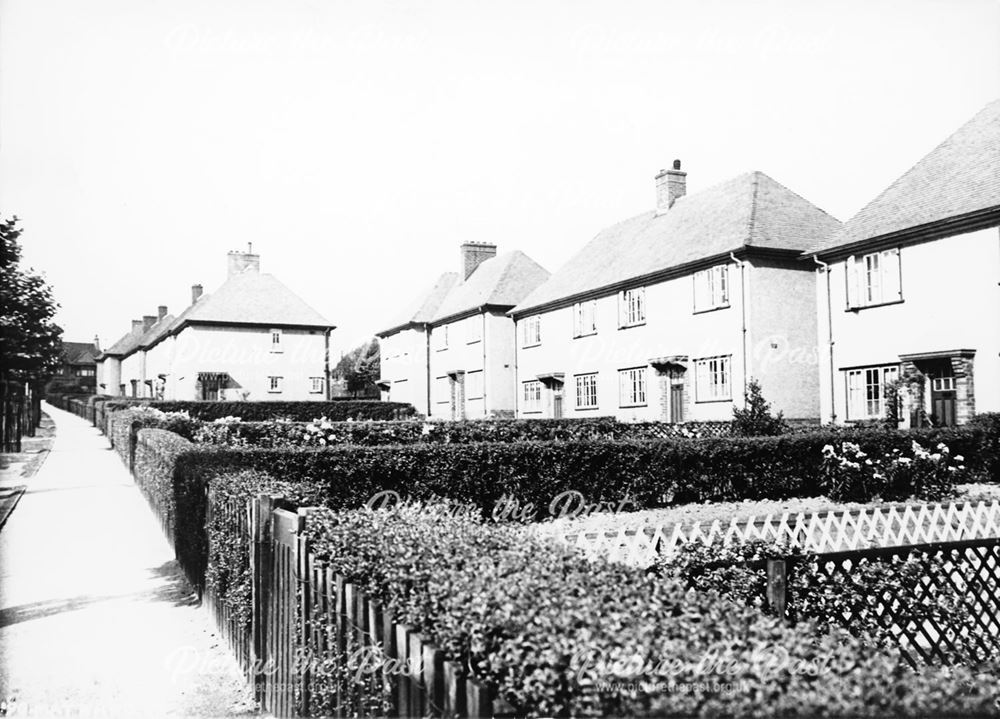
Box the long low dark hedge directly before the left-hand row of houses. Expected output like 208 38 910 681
106 399 417 422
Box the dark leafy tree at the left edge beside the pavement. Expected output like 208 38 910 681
0 217 62 387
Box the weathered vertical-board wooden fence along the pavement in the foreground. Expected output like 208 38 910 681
195 491 499 717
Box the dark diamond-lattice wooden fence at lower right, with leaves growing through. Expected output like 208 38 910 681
720 538 1000 667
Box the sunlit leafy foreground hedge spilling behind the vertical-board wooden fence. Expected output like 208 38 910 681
307 504 997 716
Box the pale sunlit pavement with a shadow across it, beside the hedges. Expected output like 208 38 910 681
0 407 254 717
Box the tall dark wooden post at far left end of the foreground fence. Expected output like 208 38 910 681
249 494 274 702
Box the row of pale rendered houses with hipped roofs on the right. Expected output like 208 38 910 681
378 101 1000 425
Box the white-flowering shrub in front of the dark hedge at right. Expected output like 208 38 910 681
820 440 968 501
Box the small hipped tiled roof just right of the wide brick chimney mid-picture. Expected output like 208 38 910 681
433 250 549 321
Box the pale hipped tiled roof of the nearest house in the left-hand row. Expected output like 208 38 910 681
180 270 330 330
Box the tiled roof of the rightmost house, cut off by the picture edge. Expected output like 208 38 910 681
810 100 1000 252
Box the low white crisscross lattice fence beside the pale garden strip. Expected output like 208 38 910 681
536 500 1000 566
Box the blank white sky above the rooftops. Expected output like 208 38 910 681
0 0 1000 356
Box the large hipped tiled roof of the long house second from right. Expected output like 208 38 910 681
514 172 840 312
